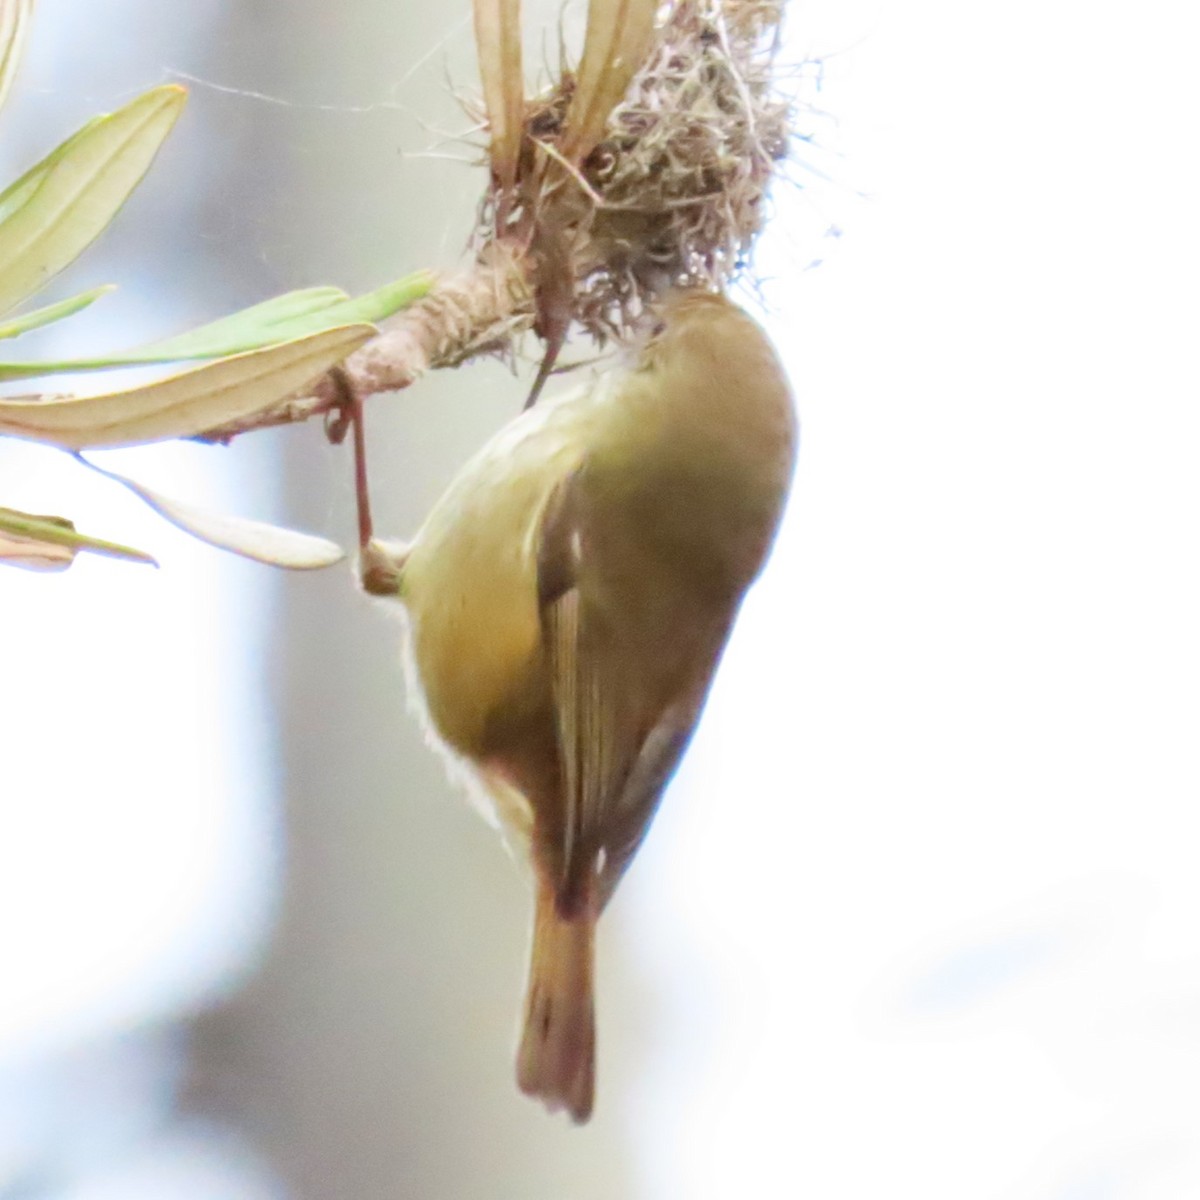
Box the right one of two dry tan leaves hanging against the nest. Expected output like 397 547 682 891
558 0 658 164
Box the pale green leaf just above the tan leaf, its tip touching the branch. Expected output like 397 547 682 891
0 271 433 380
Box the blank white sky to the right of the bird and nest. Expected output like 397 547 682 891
613 0 1200 1200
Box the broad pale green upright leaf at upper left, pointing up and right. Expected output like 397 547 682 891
0 84 187 312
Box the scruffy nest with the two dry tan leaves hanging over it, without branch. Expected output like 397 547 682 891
475 0 792 350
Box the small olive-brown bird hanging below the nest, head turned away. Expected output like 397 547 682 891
362 288 797 1123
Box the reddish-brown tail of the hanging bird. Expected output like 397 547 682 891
517 880 595 1123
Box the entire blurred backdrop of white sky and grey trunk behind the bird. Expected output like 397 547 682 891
0 0 1200 1200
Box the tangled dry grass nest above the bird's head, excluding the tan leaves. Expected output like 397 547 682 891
475 0 794 342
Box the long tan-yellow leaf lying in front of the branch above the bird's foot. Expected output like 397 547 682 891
0 325 374 450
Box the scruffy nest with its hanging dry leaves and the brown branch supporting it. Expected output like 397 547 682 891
211 0 811 439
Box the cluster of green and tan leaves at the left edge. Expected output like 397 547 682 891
0 9 433 570
